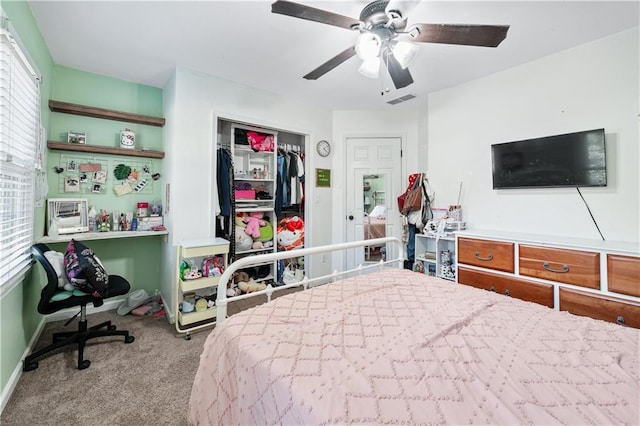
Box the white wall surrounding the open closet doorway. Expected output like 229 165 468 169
162 69 332 313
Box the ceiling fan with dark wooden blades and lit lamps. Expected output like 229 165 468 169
271 0 509 89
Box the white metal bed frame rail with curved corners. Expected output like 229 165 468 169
216 237 404 324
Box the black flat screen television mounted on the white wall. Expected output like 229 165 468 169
491 129 607 189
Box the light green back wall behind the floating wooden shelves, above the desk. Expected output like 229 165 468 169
47 65 164 220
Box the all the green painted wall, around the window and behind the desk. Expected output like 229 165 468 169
0 1 164 400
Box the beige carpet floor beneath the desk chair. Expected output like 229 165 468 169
0 294 282 426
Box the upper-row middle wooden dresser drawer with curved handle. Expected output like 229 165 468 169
519 245 600 290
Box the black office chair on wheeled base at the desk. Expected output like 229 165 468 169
22 244 135 371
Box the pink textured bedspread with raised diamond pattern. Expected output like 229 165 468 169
189 269 640 425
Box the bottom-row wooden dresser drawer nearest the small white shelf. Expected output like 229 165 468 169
458 266 553 308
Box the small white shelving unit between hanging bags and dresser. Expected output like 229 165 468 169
415 234 456 281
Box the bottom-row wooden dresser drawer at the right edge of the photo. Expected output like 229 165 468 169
560 288 640 328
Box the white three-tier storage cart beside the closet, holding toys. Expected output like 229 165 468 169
174 238 229 340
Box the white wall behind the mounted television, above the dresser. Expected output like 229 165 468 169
428 28 640 242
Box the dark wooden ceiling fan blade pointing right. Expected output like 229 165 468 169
408 24 509 47
